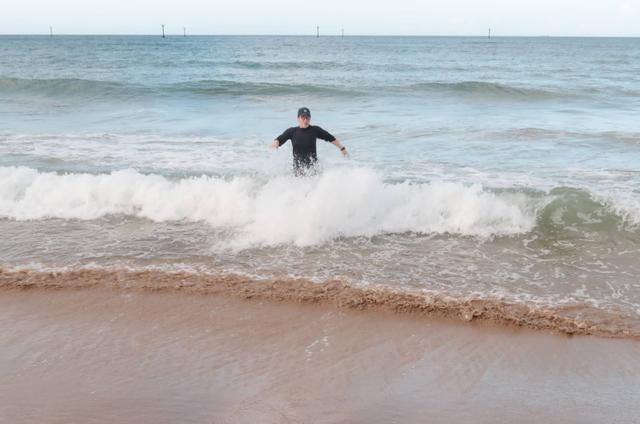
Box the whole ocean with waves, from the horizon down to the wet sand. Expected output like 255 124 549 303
0 35 640 338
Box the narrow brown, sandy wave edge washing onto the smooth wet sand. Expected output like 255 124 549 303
0 268 640 340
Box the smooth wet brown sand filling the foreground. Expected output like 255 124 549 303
0 288 640 423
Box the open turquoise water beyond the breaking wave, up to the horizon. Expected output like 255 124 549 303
0 36 640 186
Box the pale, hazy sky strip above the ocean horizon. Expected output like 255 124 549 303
0 0 640 37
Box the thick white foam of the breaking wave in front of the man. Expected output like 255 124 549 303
0 167 539 247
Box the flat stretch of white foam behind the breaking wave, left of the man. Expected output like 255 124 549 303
0 132 282 175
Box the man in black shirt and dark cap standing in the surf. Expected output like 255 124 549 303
271 107 349 176
